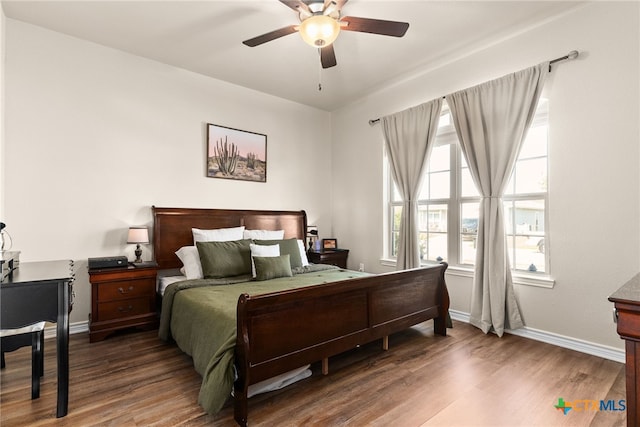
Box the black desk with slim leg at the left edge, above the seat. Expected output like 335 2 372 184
0 261 74 418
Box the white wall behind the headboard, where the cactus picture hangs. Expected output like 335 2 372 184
2 19 331 323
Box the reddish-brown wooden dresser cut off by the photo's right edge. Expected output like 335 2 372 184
609 273 640 427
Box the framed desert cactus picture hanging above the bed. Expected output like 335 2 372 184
207 123 267 182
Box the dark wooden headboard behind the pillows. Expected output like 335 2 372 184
151 206 307 269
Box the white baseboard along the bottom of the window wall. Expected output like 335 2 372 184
449 310 625 363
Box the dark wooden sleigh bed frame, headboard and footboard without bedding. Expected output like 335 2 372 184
153 207 449 425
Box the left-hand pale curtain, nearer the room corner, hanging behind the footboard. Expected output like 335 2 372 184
380 98 442 270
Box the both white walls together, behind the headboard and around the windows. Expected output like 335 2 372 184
5 2 640 354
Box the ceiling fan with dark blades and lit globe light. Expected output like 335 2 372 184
242 0 409 68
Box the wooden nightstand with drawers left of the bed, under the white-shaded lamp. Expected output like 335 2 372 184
89 263 158 342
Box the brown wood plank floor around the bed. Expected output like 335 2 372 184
0 322 626 427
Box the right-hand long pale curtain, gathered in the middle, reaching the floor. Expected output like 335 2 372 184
446 62 549 336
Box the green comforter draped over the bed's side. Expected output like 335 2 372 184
159 264 368 414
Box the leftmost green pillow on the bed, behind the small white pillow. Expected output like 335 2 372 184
196 240 251 279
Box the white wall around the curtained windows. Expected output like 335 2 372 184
332 2 640 349
